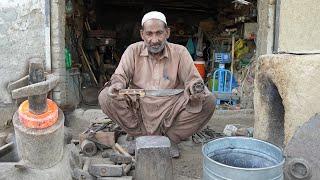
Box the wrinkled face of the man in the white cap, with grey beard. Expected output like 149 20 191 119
140 19 170 54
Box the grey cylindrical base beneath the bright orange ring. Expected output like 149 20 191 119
12 110 64 169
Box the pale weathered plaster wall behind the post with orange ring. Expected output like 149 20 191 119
0 0 45 127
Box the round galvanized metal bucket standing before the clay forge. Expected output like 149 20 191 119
202 137 285 180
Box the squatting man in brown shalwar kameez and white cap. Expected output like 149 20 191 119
99 11 215 156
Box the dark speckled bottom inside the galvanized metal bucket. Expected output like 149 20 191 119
210 148 278 168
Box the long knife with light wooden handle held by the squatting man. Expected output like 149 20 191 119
119 89 184 97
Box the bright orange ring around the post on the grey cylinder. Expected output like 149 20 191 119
18 99 58 129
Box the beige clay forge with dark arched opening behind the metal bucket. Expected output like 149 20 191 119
254 54 320 147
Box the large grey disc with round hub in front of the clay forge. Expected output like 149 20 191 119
284 114 320 180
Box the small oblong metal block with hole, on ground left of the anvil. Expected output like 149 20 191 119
89 164 123 177
